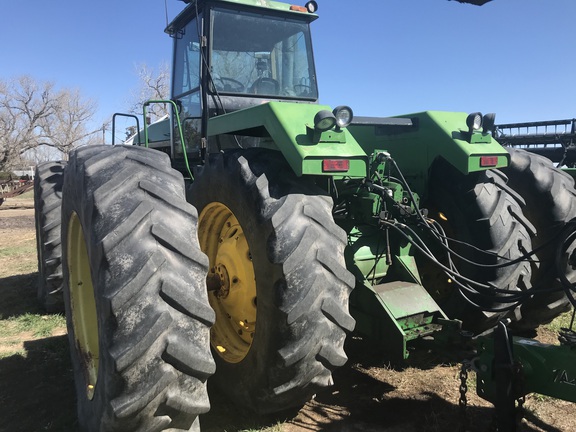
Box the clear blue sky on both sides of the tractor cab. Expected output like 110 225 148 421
0 0 576 142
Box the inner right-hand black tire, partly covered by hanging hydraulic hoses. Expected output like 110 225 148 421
424 161 535 333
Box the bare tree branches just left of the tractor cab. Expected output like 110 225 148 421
129 62 170 121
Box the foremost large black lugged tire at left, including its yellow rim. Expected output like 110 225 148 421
62 146 215 432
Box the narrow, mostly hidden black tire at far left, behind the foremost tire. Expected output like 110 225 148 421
34 161 66 313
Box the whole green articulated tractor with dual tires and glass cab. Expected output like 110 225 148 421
36 0 576 431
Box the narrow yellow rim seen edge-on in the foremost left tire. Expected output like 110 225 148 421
67 213 100 400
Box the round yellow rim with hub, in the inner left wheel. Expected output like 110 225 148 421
198 203 256 363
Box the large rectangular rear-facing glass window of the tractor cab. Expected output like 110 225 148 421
210 9 318 100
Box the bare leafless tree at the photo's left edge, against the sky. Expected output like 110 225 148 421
0 76 96 171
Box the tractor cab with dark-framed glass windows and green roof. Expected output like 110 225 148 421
166 0 318 171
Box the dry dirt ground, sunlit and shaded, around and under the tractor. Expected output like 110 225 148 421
0 200 576 432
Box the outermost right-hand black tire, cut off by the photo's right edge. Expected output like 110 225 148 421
501 148 576 330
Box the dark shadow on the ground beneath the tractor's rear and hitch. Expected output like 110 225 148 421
201 338 567 432
